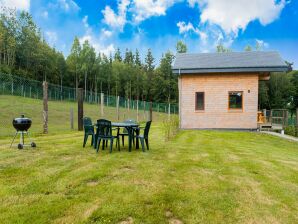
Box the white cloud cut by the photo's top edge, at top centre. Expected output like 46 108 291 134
133 0 180 23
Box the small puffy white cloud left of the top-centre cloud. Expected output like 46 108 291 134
102 0 130 31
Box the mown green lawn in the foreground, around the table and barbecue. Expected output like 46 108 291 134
0 123 298 224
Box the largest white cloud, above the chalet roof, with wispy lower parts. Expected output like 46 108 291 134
177 0 287 51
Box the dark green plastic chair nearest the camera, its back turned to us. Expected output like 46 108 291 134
96 119 120 153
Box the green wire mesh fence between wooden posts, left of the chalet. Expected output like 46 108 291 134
0 73 179 136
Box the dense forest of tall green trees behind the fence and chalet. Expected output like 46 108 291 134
0 9 298 111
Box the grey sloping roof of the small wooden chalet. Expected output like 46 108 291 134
172 51 289 74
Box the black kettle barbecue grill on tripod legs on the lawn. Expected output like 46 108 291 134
10 115 36 149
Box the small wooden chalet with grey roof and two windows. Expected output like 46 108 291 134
173 51 288 130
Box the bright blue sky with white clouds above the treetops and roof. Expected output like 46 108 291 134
0 0 298 69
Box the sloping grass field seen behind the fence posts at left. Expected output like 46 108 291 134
0 95 170 136
